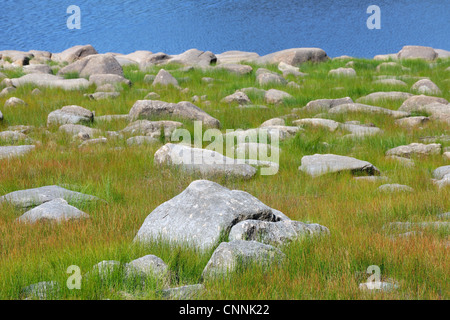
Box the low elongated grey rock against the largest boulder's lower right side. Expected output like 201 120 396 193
228 220 329 245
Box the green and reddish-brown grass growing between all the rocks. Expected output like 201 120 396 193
0 59 450 299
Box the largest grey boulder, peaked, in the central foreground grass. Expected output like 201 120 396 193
134 180 281 250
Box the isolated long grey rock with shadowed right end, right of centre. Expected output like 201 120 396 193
299 154 380 177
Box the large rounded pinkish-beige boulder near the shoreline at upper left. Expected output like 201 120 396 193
58 54 123 77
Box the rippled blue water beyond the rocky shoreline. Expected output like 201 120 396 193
0 0 450 58
